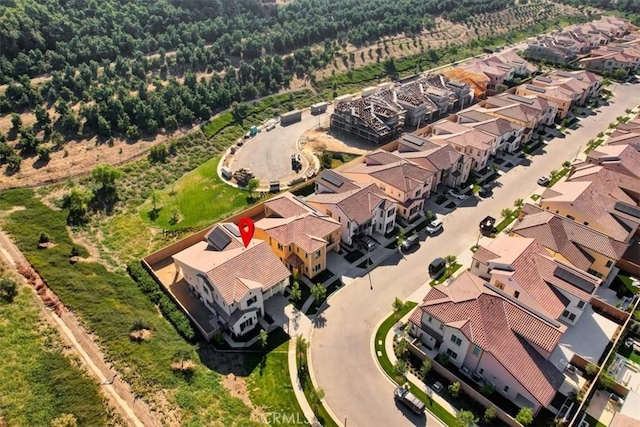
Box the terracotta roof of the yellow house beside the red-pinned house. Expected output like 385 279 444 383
255 214 341 253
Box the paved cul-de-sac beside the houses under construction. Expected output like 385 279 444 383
231 106 332 184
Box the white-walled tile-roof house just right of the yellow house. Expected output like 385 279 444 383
307 170 397 245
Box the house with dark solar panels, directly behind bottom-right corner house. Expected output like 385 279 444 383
470 235 601 325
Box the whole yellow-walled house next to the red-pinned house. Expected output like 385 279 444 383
255 193 342 278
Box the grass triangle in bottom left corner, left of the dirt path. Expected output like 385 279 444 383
0 265 110 426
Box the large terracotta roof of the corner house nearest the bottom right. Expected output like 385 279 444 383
411 275 566 406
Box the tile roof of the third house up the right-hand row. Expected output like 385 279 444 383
512 205 628 264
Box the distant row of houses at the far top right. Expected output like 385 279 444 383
524 16 629 64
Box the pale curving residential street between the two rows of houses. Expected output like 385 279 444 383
311 85 640 427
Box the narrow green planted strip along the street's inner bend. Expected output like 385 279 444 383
374 302 456 426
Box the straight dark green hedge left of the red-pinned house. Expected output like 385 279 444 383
127 261 195 341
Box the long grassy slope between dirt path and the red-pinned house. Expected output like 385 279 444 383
0 190 262 426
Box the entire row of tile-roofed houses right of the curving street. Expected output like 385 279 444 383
410 145 640 412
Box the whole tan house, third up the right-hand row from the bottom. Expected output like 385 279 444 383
510 204 629 283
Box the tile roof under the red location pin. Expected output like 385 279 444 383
173 231 290 304
